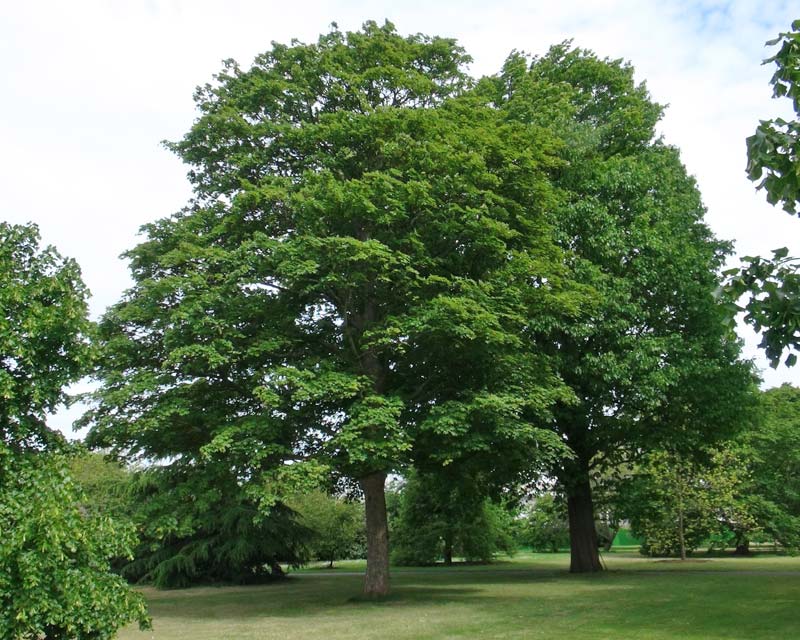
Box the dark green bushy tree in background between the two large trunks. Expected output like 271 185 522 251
391 472 516 565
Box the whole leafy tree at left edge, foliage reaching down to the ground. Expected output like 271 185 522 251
0 222 148 640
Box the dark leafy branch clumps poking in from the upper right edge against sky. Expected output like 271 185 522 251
727 20 800 367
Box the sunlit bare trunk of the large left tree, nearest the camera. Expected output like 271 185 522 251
360 472 389 597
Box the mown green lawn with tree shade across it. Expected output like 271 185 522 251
118 553 800 640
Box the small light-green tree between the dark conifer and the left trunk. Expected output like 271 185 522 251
288 490 366 568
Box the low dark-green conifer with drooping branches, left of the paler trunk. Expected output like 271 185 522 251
122 465 310 587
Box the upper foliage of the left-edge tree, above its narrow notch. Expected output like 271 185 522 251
0 222 90 448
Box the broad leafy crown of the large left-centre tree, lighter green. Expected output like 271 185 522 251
81 23 579 591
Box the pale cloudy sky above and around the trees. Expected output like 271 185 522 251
0 0 800 430
